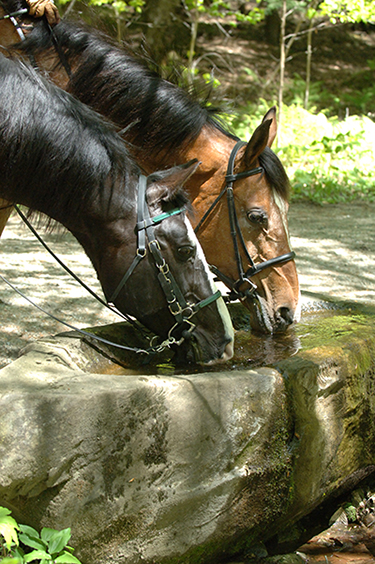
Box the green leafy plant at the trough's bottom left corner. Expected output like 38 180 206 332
0 507 80 564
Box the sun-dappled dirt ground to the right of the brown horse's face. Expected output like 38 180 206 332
289 203 375 303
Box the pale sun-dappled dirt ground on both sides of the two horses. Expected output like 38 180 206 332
0 199 375 367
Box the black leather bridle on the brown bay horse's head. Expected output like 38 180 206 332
195 141 296 301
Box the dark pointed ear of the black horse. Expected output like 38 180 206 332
147 159 201 205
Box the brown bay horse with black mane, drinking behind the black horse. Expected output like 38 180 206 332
0 0 299 333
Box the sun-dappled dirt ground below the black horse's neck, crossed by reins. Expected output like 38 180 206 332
0 216 119 366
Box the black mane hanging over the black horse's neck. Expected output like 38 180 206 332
0 55 138 218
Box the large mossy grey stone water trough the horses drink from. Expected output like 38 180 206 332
0 304 375 564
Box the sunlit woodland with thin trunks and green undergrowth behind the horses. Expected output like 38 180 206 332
49 0 375 203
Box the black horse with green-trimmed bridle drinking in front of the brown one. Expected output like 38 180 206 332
0 56 233 362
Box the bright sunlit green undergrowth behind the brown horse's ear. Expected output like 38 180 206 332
228 100 375 204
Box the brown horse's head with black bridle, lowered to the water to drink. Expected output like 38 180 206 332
194 108 299 333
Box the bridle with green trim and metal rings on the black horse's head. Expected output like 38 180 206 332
108 175 221 348
